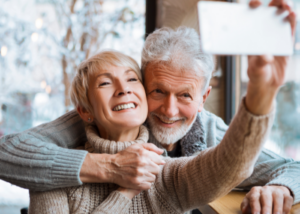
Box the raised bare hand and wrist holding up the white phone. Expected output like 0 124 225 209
245 0 296 115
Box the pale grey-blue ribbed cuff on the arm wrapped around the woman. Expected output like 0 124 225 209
51 148 88 187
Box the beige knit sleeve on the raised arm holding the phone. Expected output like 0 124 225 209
155 100 274 212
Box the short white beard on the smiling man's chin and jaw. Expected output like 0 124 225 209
148 113 197 145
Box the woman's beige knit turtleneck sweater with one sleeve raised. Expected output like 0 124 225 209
29 101 274 214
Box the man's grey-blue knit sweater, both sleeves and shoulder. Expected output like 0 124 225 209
0 100 300 204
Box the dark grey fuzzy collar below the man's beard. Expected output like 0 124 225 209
146 113 207 157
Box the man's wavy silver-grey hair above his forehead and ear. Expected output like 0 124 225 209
142 27 214 93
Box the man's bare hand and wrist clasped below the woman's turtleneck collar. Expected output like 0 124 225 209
80 143 165 190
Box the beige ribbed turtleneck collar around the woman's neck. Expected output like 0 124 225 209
85 124 149 154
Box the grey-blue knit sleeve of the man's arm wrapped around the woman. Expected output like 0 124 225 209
0 111 87 191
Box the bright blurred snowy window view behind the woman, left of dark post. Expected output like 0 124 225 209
0 0 145 211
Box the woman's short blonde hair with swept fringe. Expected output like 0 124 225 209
70 51 142 113
